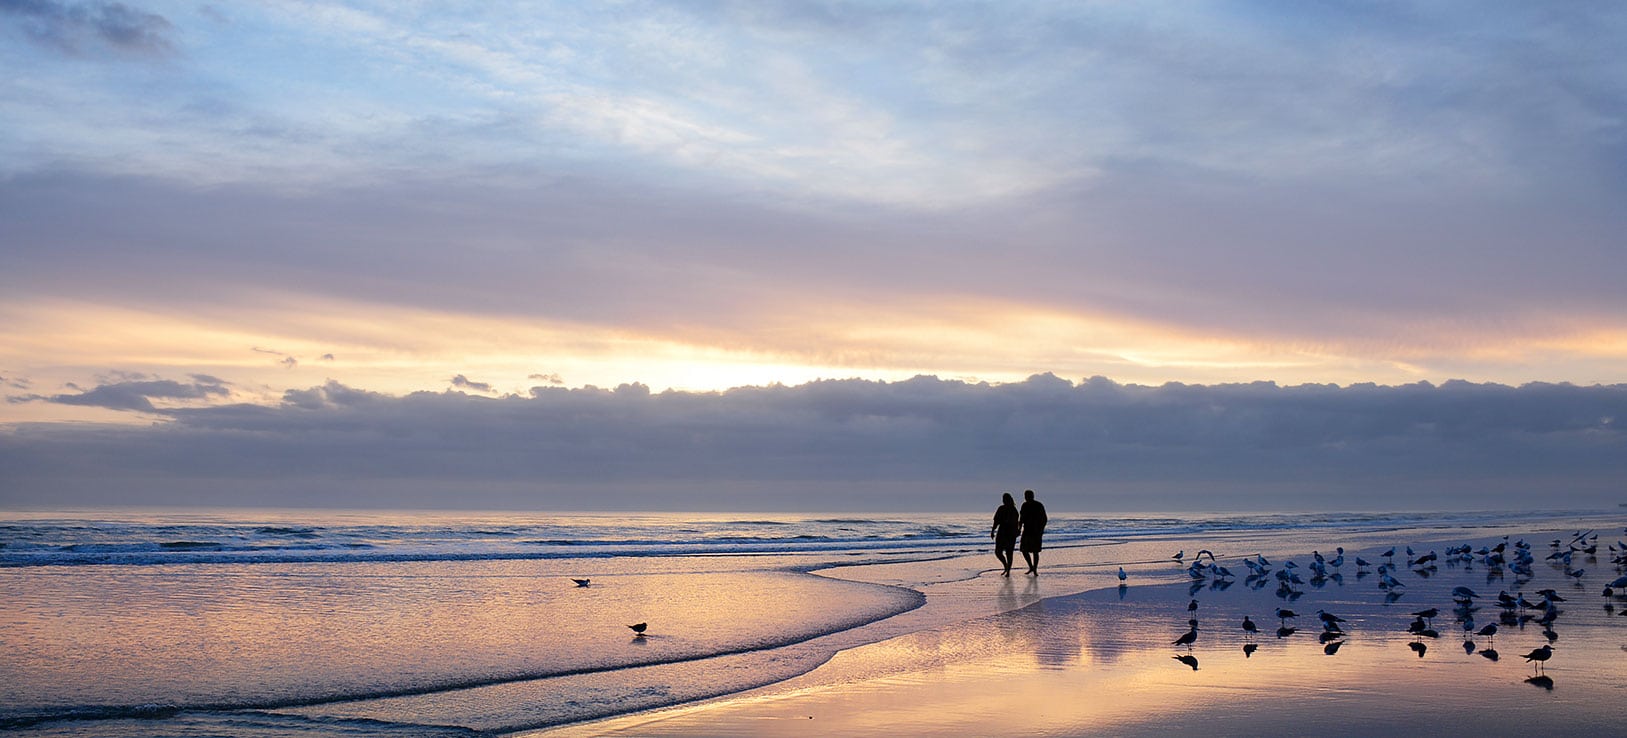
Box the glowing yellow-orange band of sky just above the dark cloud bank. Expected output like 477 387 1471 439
0 290 1627 423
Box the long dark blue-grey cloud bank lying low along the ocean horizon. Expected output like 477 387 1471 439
0 374 1627 514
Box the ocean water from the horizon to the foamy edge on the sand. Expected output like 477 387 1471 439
0 506 1620 736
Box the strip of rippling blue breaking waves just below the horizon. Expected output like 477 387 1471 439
0 510 1588 567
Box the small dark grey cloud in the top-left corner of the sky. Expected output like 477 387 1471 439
0 0 174 55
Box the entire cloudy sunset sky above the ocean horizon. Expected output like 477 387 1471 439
0 0 1627 510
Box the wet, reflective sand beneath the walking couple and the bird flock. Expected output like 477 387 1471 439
532 517 1627 738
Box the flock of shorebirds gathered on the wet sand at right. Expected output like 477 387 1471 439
1158 530 1627 689
